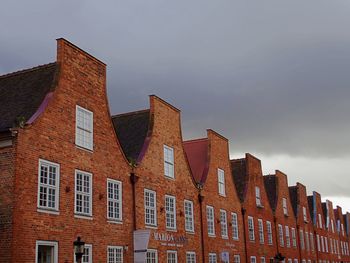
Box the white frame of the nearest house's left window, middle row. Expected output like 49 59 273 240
37 159 60 212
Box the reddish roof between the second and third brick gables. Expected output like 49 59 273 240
183 138 209 185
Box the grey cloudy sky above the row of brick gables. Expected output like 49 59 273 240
0 0 350 211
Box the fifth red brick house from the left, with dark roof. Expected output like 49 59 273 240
264 170 300 263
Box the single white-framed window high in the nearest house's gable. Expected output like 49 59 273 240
75 105 94 150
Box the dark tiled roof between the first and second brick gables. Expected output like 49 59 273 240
112 109 150 162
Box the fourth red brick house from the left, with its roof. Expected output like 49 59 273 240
231 154 277 263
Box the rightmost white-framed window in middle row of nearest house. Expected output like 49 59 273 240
107 179 123 221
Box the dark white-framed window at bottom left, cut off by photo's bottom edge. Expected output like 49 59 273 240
35 240 58 263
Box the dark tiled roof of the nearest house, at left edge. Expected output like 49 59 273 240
0 62 59 132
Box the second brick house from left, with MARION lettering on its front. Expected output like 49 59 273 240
112 95 202 263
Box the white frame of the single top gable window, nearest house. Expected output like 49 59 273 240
75 105 94 151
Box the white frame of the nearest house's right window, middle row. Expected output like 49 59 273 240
107 178 123 221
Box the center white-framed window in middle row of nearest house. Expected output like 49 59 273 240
74 170 92 216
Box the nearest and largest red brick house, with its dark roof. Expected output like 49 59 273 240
0 39 133 263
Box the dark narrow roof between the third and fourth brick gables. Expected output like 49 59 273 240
231 158 249 203
